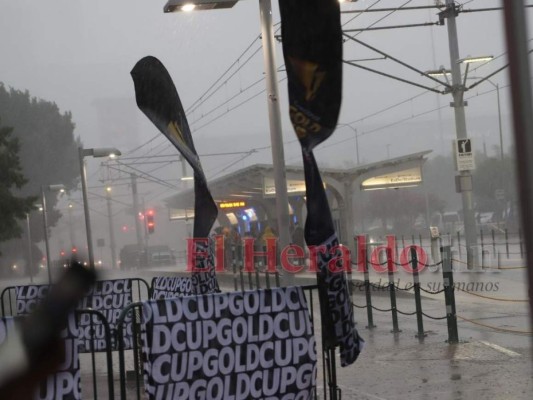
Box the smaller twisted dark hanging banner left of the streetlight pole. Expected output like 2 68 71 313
131 56 220 293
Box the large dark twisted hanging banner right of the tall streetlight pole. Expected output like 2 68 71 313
279 0 363 366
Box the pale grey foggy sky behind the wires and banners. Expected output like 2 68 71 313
0 0 524 260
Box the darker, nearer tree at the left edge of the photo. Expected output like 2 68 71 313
0 120 36 245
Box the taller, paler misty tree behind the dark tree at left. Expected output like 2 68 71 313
0 82 81 263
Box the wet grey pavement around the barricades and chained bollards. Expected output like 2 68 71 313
4 262 533 400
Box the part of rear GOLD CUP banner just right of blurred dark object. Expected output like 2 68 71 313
78 279 133 353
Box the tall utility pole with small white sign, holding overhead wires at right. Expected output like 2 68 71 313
441 0 477 269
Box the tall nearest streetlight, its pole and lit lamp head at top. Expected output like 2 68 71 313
164 0 293 285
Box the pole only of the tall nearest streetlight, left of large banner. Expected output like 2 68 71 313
259 0 294 286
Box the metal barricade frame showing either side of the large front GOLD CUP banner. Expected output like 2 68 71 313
117 285 341 400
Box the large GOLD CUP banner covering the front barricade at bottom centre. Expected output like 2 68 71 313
142 287 317 400
